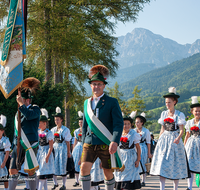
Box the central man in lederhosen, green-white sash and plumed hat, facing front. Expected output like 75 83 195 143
80 65 123 190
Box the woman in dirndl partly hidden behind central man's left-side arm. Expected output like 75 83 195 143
72 111 83 187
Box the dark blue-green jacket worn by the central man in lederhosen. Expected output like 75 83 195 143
82 95 124 145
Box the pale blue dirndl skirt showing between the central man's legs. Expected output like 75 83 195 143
90 158 104 186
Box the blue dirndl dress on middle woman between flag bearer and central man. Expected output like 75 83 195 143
51 126 71 176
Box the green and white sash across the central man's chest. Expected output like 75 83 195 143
84 98 125 171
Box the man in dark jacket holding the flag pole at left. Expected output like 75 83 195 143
9 90 41 190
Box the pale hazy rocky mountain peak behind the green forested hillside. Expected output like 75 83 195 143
116 28 200 69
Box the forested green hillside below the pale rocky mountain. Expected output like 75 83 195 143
120 53 200 99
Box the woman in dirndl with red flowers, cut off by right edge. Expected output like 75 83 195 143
184 96 200 190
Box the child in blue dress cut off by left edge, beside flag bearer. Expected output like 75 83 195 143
0 115 11 190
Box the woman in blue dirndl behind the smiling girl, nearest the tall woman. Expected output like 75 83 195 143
134 112 152 187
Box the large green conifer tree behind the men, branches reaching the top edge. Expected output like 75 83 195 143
0 0 150 127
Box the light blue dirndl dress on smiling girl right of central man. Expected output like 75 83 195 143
114 129 141 189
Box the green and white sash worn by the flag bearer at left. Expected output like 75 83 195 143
14 114 39 172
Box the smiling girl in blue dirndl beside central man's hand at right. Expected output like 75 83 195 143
114 112 141 190
